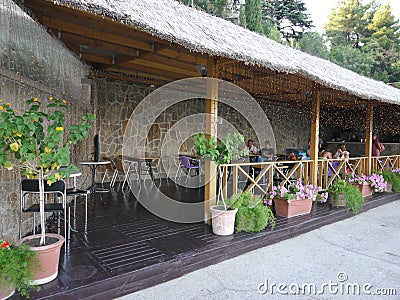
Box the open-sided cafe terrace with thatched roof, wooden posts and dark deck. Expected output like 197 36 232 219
0 0 400 298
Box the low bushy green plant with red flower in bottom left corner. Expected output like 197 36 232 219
0 240 37 299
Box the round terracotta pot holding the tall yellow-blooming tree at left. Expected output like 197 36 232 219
20 233 64 285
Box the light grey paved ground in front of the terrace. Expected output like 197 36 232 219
119 201 400 300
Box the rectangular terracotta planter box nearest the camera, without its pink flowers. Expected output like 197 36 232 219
274 198 313 218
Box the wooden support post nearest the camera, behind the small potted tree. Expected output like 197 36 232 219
204 57 218 223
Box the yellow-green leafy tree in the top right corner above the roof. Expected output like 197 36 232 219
325 0 400 82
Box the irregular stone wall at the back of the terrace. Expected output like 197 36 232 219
96 79 311 164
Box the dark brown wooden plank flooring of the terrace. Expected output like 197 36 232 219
12 182 400 299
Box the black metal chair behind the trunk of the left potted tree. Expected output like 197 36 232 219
19 179 67 250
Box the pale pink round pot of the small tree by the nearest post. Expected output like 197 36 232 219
210 205 237 235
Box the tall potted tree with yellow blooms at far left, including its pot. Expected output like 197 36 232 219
0 97 95 284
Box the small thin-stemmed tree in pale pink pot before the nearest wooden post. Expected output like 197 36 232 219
194 133 244 235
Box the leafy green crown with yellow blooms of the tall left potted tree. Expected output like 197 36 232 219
0 97 95 184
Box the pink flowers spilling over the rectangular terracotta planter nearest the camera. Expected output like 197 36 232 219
265 179 328 203
